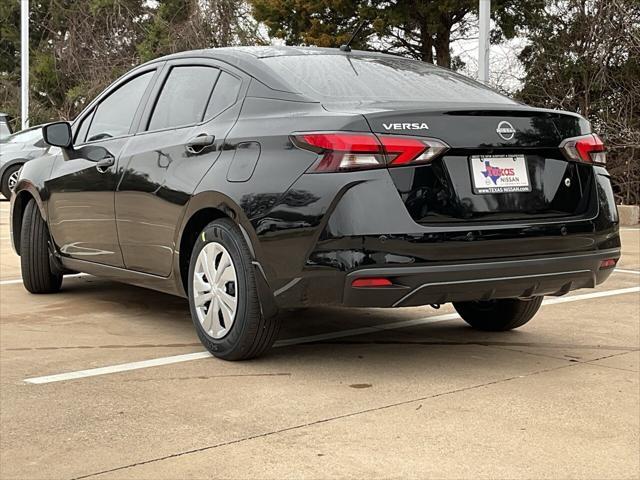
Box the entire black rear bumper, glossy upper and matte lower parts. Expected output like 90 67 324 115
256 165 620 308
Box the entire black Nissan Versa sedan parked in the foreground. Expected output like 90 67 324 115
11 47 620 360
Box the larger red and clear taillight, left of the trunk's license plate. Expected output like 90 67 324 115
291 132 449 172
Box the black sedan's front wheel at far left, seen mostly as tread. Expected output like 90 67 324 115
20 200 62 293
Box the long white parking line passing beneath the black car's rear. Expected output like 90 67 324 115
24 287 640 384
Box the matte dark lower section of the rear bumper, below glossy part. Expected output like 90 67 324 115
342 249 620 307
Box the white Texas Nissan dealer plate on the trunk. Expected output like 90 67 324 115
469 154 531 195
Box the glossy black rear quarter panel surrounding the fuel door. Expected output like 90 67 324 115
183 97 370 279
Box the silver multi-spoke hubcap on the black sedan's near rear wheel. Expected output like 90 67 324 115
193 242 238 339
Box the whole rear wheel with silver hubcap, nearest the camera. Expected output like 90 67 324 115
189 218 280 360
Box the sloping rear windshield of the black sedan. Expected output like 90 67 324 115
262 55 515 104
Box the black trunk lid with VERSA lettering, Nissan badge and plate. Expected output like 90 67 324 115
325 103 594 224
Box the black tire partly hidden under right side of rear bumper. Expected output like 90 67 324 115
453 296 543 332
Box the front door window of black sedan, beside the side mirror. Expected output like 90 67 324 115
87 71 155 142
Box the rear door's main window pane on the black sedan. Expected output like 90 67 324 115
148 66 220 130
